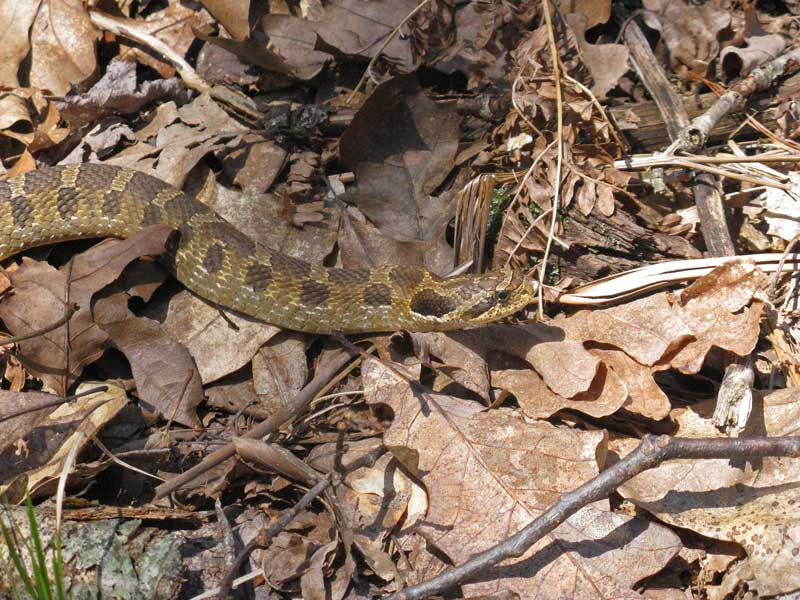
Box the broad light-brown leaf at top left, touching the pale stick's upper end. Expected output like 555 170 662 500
28 0 99 96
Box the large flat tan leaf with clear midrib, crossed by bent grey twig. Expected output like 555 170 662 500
362 360 680 599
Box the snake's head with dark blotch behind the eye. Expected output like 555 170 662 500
410 267 537 331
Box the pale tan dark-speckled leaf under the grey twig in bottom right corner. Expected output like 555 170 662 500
617 389 800 596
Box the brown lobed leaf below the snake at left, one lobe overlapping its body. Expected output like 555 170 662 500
0 225 172 395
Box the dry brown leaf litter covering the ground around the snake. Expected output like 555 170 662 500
0 0 800 600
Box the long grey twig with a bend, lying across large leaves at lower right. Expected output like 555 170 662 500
386 434 800 600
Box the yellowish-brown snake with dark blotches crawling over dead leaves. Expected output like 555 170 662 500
0 163 536 334
